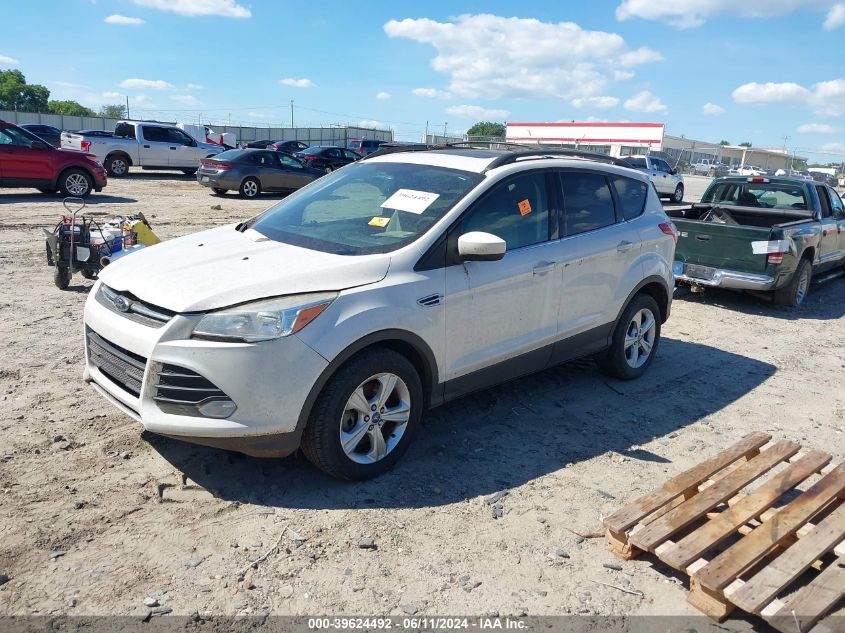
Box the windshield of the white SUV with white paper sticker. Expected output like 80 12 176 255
252 162 483 255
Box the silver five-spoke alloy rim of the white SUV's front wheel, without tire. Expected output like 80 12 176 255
340 373 411 464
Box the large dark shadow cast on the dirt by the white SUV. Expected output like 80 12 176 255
144 338 776 509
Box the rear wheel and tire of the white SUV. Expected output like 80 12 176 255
599 294 660 380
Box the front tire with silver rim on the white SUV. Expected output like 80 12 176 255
302 348 423 480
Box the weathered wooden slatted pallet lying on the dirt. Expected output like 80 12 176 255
604 433 845 633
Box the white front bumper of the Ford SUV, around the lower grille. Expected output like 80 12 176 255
84 282 328 455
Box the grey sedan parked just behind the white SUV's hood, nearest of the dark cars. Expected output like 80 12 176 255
197 149 325 198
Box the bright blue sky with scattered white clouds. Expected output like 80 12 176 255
0 0 845 162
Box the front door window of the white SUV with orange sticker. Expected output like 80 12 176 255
461 172 549 251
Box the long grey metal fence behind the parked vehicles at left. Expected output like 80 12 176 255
0 110 393 146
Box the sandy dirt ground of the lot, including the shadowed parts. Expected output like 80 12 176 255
0 173 845 629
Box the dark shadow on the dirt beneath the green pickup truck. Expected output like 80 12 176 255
674 277 845 321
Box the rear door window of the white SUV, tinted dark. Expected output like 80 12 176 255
561 172 616 235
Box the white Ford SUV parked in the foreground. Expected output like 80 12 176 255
85 148 677 479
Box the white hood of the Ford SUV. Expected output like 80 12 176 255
99 224 390 312
